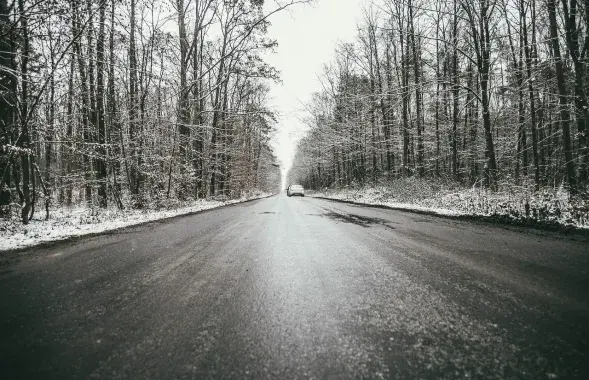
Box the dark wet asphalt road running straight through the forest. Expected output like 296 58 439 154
0 195 589 379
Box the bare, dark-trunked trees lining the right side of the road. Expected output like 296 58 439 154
289 0 589 194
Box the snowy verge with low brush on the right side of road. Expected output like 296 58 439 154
309 179 589 229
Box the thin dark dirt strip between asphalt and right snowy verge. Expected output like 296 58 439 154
309 195 589 241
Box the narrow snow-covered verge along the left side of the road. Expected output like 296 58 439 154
0 193 270 252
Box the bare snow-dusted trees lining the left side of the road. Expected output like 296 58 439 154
0 0 284 223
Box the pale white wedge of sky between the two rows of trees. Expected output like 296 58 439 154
265 0 363 180
